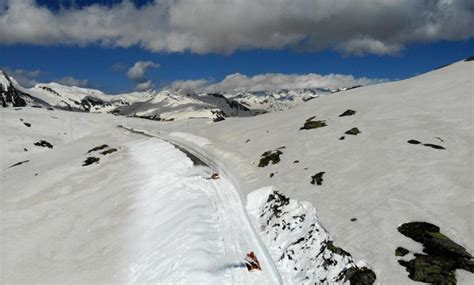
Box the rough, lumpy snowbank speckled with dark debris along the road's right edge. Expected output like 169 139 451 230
247 187 362 284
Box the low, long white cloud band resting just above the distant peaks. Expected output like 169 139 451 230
165 73 385 92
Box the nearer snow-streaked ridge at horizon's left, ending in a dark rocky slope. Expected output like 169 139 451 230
0 71 265 121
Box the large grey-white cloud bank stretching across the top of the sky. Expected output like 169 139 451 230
0 0 474 55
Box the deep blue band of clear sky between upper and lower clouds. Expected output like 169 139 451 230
0 0 474 93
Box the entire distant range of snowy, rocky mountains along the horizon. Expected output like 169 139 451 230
1 71 356 121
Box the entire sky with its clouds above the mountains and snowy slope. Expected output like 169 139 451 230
0 0 474 93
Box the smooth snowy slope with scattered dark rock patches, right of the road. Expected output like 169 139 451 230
121 58 474 284
